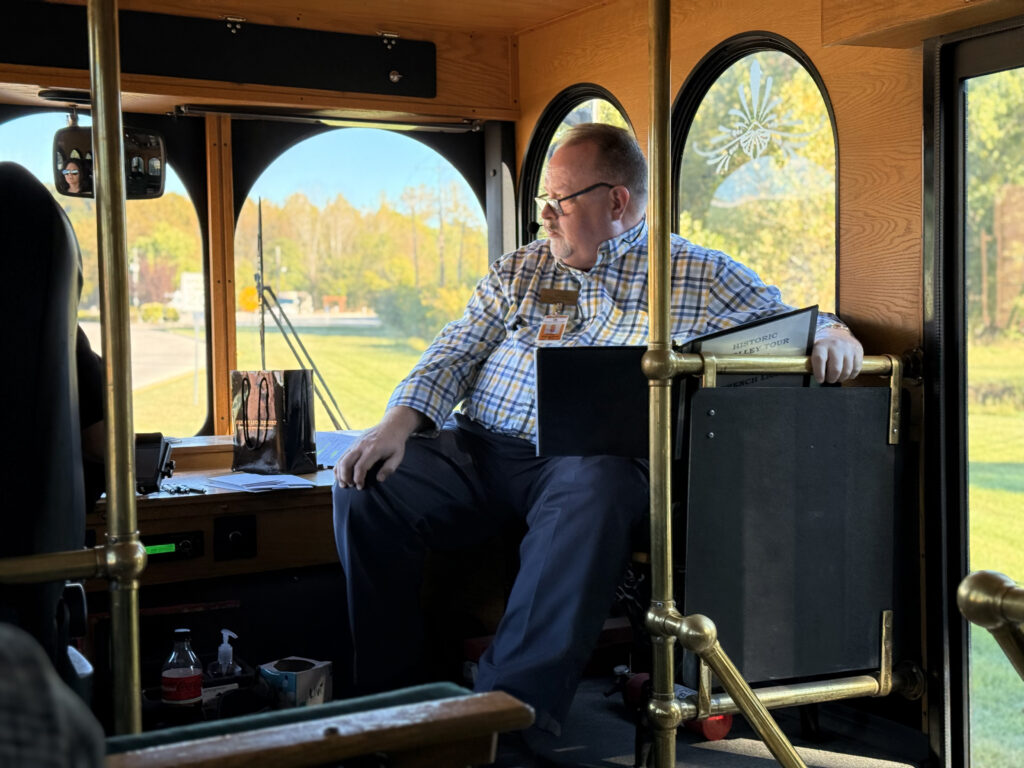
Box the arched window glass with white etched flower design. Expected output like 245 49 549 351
678 51 836 311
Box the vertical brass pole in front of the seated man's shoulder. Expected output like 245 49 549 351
647 0 682 768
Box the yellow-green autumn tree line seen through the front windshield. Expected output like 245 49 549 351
59 181 487 337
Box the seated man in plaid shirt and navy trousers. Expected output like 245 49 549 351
334 124 862 734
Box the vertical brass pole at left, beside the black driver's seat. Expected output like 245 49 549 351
88 0 142 733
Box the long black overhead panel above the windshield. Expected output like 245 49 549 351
0 3 437 98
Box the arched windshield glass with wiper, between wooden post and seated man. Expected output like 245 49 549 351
234 128 487 430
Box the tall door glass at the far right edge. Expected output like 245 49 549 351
964 61 1024 766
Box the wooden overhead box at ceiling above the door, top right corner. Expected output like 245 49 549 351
821 0 1024 48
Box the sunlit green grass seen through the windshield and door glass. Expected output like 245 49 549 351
135 329 1024 768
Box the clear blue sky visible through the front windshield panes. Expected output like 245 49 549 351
0 113 483 224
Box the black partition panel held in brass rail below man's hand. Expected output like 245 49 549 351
683 387 899 683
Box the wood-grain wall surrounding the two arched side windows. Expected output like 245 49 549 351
517 0 923 353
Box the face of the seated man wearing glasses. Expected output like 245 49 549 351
541 142 617 269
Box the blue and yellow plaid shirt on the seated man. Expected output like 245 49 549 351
388 219 836 442
